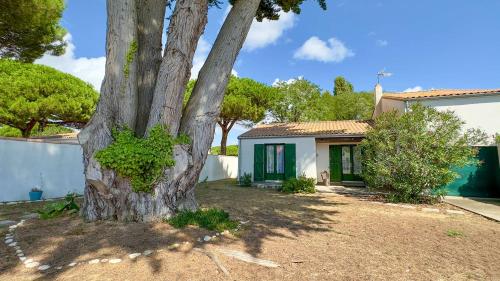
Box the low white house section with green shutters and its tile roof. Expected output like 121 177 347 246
238 120 371 184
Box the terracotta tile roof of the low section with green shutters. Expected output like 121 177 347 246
239 120 372 138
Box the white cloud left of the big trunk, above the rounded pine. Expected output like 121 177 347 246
35 33 106 91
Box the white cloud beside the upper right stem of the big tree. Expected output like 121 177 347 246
243 11 297 51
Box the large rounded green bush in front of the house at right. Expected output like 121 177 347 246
361 104 484 203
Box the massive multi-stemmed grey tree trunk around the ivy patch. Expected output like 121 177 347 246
79 0 260 221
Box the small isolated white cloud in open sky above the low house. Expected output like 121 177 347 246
293 36 354 62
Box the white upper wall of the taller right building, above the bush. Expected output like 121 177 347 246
382 95 500 144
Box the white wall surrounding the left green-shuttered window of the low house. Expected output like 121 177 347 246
239 137 317 178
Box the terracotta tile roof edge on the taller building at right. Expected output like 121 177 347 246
382 89 500 100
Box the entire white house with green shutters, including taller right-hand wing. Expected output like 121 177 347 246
238 84 500 197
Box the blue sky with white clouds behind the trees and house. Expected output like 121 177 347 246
38 0 500 144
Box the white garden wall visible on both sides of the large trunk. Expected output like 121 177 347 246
0 139 238 202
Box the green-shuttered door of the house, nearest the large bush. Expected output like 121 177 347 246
330 145 362 182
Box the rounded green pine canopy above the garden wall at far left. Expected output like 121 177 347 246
0 59 98 137
